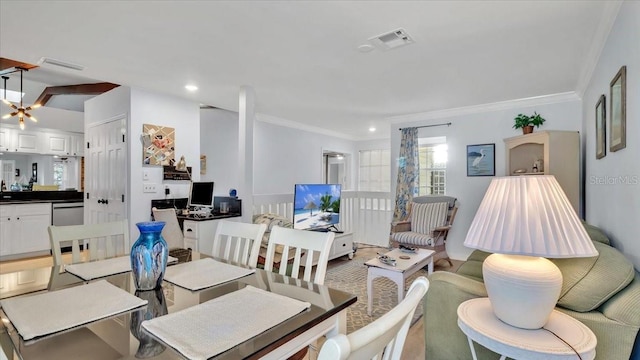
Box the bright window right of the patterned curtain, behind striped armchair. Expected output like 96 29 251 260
418 137 447 195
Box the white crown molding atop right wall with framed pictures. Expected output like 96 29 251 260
576 1 624 98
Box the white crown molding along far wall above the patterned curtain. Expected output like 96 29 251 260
387 91 580 124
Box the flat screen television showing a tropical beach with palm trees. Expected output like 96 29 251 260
293 184 341 230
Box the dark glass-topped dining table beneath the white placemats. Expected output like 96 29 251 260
0 253 356 360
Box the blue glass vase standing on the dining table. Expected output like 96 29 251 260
131 221 169 290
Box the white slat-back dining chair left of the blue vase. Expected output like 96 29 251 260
48 219 131 265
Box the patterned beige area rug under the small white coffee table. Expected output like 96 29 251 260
324 248 428 333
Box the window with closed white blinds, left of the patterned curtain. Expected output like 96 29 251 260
358 149 391 192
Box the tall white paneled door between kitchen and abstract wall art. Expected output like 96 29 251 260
84 116 128 224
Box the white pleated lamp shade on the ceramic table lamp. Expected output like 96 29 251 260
464 175 598 258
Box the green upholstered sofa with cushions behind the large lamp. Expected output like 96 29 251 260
423 223 640 360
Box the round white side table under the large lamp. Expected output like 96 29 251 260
458 298 597 360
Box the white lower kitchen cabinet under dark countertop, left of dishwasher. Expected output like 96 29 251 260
0 203 51 260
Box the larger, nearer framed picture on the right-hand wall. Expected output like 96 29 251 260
609 66 627 152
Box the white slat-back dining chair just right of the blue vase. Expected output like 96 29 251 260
211 220 267 268
